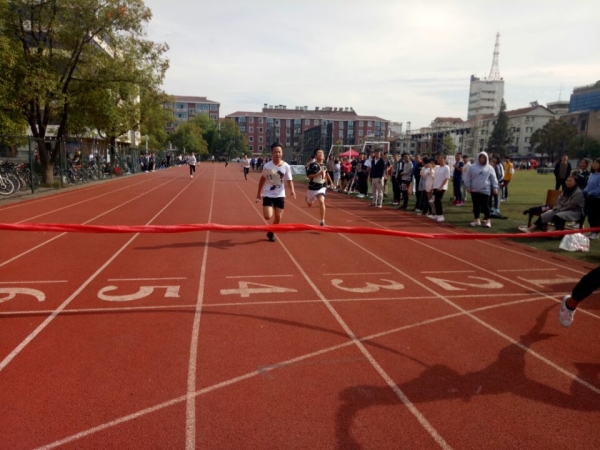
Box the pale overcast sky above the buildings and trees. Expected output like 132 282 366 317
145 0 600 129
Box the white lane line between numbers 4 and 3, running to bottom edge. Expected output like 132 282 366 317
232 178 452 450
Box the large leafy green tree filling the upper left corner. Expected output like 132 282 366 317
0 0 168 183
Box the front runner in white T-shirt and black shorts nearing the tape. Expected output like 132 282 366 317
256 142 296 242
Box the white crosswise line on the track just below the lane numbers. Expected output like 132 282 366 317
0 292 564 316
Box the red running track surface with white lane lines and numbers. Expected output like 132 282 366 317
0 164 600 449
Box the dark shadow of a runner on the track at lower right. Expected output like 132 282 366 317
335 305 600 450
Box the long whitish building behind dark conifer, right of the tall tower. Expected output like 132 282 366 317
475 102 557 155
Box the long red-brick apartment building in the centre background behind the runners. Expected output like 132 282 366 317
226 104 389 154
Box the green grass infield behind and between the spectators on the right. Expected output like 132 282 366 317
294 170 600 264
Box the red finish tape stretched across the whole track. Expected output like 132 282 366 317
0 223 600 240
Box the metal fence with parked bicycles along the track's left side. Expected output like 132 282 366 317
0 135 175 196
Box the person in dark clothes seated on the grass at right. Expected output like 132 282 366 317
521 175 585 233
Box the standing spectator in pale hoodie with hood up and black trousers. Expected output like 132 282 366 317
465 152 498 228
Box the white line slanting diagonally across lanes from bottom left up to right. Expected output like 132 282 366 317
38 298 543 450
